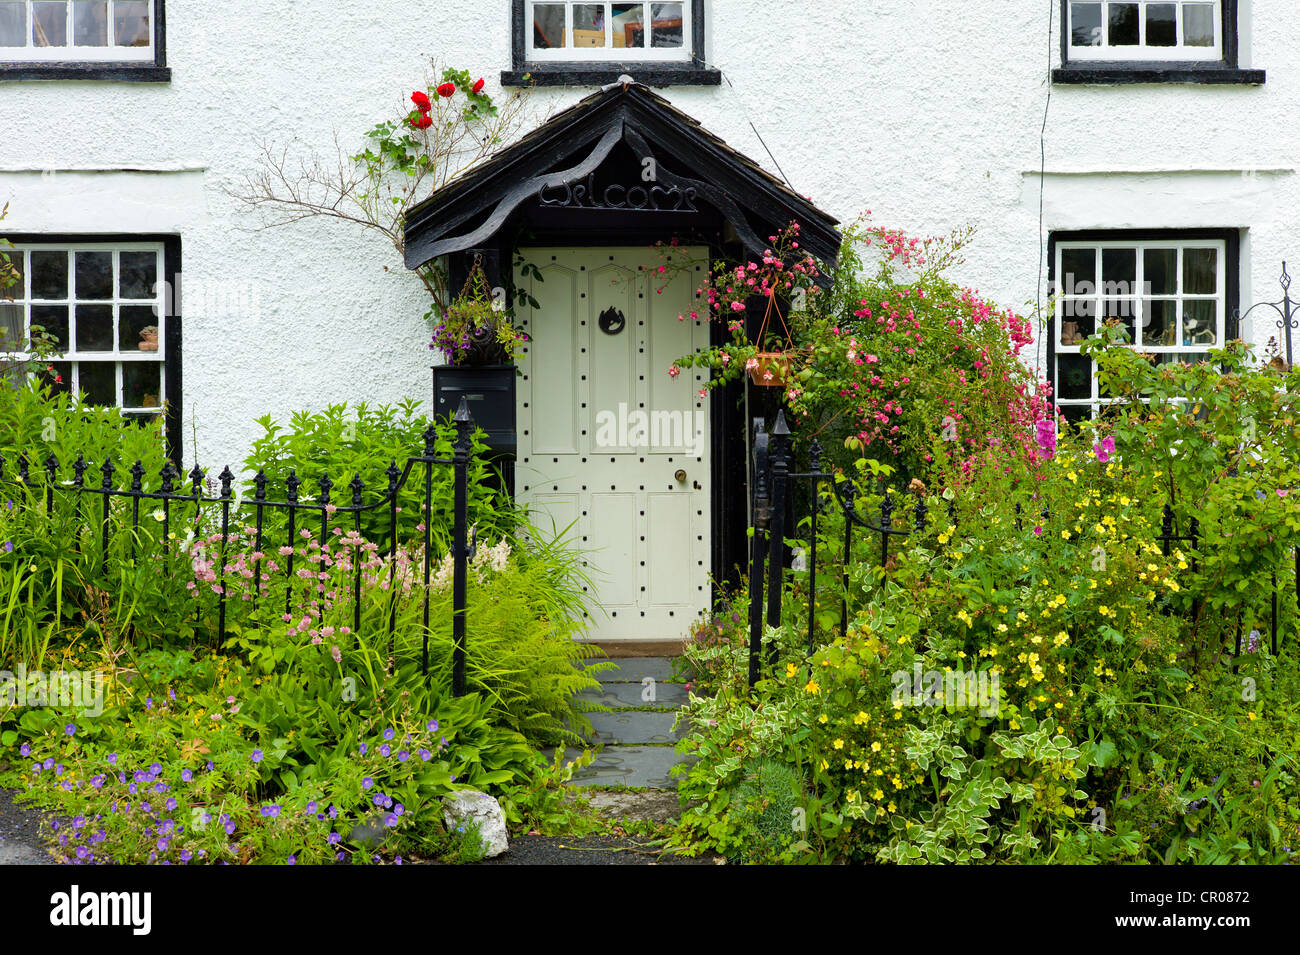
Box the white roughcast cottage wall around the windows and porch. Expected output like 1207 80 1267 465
0 0 1300 466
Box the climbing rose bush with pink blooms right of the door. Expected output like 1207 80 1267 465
675 222 1054 479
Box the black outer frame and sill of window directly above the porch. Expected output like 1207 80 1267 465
501 0 723 87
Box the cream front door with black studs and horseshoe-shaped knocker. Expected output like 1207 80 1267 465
515 248 711 643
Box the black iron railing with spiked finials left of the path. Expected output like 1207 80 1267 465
0 399 476 696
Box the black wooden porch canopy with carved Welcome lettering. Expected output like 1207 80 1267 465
406 77 840 269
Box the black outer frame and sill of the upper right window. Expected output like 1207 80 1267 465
1052 0 1265 86
